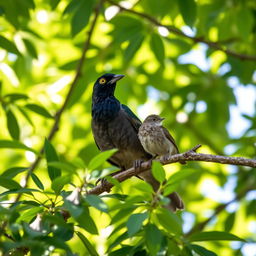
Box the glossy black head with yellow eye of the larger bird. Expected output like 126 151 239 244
93 73 124 98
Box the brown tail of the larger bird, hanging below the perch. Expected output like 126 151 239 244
139 170 184 212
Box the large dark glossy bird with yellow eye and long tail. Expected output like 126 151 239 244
92 74 183 211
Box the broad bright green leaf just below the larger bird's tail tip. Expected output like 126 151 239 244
156 208 182 235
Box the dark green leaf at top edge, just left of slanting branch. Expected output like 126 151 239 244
71 0 94 37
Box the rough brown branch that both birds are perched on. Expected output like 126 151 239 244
87 145 256 195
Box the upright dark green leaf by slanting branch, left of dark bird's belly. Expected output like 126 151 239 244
44 139 61 181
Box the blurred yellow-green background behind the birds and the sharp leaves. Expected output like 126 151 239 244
0 0 256 256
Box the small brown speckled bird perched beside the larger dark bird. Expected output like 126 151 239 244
138 115 186 211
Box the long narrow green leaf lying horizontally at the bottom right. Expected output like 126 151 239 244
188 231 245 242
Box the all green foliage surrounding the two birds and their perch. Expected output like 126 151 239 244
0 0 256 256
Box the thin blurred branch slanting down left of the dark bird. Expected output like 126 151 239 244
15 0 103 202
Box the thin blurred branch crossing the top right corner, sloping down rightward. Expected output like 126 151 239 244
107 0 256 61
